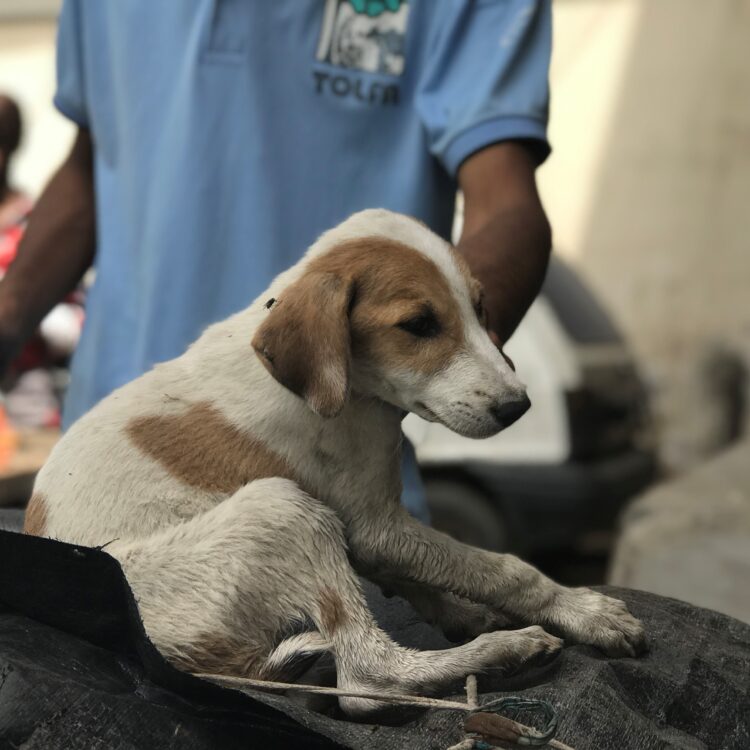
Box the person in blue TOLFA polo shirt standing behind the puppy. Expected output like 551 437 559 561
0 0 551 524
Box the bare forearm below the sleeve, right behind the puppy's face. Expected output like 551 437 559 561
458 141 552 344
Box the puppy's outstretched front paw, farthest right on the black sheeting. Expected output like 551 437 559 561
549 588 646 656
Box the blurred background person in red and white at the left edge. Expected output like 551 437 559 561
0 94 83 427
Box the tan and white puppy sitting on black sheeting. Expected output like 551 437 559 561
26 210 644 713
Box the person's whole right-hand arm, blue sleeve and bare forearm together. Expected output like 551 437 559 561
416 0 552 343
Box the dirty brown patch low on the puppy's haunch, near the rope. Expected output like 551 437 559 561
168 634 267 679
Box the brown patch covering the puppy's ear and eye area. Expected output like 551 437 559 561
253 236 470 416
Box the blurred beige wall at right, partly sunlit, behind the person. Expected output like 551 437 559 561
540 0 750 402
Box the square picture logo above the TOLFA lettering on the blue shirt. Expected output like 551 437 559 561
315 0 409 76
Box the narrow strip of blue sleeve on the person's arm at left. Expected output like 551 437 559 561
53 0 89 127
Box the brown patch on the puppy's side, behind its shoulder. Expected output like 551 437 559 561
126 403 294 495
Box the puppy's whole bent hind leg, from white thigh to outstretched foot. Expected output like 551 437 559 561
108 479 560 713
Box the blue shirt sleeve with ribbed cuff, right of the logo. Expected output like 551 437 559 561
416 0 552 176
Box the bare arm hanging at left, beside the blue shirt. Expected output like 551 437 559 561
0 128 96 373
